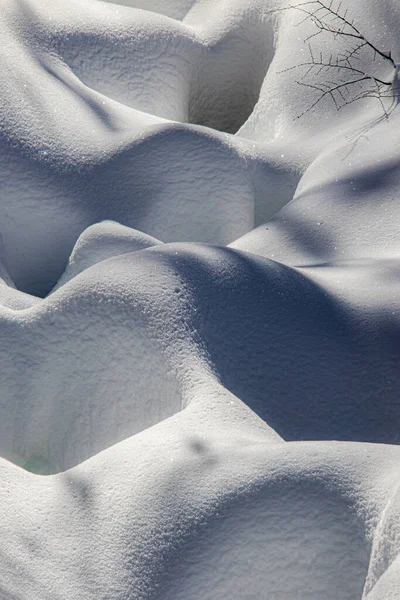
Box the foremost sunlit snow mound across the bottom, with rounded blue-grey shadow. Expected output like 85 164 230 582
0 436 399 600
